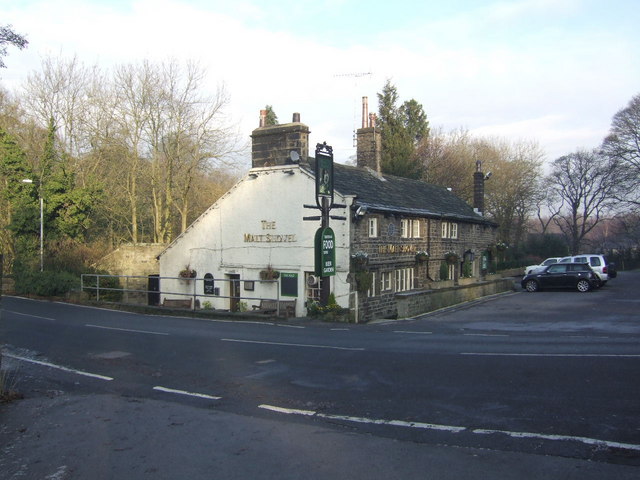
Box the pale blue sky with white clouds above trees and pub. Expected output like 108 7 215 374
0 0 640 167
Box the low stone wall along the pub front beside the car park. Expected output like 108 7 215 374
396 278 514 318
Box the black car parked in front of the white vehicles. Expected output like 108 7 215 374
520 263 600 292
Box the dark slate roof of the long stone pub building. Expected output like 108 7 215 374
301 158 495 225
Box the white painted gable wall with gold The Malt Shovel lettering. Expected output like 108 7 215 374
160 165 351 316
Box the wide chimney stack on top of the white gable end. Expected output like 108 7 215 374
251 110 309 168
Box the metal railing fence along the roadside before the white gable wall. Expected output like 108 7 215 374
80 274 295 315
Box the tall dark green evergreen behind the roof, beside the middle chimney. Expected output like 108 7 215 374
378 80 429 179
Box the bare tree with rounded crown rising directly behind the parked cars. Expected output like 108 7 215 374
549 150 619 254
